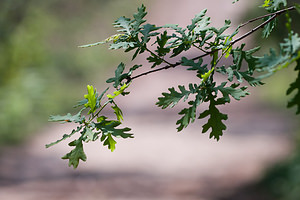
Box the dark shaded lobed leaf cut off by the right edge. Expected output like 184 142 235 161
286 59 300 115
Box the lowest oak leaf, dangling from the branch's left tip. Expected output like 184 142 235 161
62 139 86 169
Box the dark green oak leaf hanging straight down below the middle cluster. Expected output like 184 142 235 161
199 95 228 140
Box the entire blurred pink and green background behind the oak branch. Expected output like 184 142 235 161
0 0 300 200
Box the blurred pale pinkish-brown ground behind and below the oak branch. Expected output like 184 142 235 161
0 0 293 200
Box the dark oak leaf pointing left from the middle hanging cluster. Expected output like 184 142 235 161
156 85 195 109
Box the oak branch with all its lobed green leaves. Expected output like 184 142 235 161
47 0 300 168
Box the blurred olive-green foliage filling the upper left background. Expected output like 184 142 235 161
0 0 140 145
